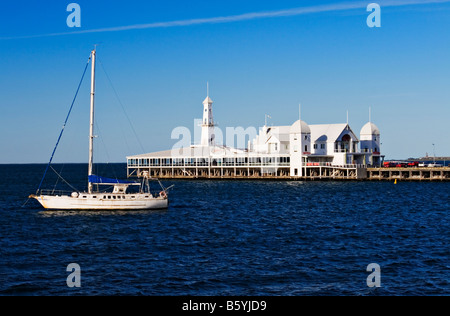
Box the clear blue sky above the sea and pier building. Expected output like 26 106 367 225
0 0 450 163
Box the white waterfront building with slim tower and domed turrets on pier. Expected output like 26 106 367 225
127 91 384 179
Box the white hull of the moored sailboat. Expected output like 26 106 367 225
31 193 169 210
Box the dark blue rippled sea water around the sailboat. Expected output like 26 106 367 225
0 165 450 296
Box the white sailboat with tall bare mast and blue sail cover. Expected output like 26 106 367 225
29 49 170 210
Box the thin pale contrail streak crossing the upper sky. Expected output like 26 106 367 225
0 0 450 40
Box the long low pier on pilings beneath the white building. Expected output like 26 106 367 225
127 159 450 181
